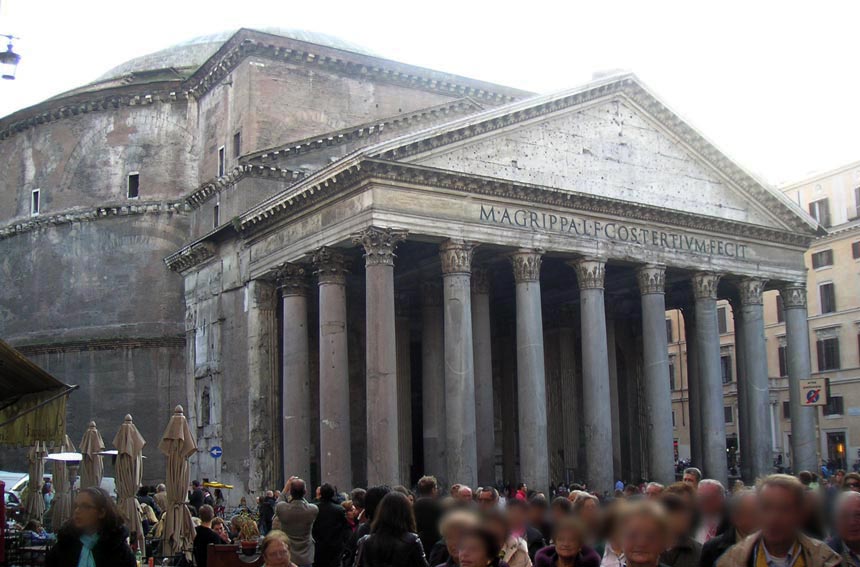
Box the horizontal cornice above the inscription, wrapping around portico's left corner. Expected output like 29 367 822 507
236 159 812 248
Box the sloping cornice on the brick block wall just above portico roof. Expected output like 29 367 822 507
242 97 484 163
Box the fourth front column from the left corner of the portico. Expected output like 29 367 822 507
571 259 615 494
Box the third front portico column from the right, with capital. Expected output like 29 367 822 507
693 273 729 484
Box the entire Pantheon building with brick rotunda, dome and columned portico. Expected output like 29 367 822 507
0 29 821 496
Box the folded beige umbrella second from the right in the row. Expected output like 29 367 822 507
113 415 146 550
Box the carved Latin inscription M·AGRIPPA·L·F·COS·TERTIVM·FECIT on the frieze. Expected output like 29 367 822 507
480 205 748 259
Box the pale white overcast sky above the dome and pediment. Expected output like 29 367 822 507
0 0 860 183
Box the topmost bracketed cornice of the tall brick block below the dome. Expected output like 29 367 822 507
186 28 532 104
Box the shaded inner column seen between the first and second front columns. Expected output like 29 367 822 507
421 282 448 484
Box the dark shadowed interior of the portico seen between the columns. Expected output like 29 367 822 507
268 235 772 492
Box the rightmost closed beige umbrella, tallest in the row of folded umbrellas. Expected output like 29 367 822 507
158 406 197 559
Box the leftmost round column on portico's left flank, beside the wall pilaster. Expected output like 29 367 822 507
276 263 311 479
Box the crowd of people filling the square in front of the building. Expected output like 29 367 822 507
30 468 860 567
